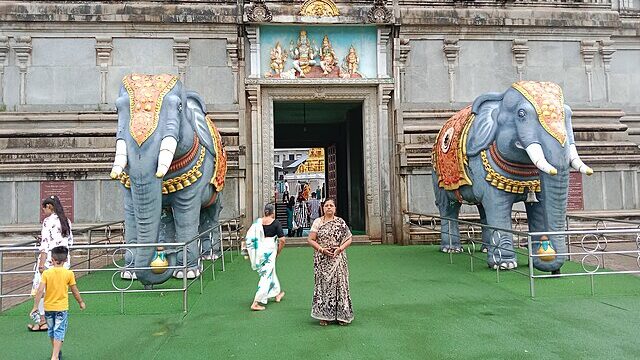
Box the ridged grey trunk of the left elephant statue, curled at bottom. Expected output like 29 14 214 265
131 176 175 285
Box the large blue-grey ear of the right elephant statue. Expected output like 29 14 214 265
467 93 504 156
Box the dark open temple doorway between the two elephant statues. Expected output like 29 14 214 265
273 101 366 236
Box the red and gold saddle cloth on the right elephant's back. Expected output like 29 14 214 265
432 106 474 190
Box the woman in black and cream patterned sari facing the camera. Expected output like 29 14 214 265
307 199 353 326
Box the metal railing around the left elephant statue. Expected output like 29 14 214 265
0 217 242 313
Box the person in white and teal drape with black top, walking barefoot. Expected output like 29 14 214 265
246 204 285 311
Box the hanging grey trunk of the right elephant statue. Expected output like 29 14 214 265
533 169 569 271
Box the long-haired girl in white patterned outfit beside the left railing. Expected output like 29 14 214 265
27 195 73 331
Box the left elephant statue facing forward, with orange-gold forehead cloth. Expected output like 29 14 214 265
110 74 227 285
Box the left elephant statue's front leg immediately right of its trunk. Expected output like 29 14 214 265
172 199 200 278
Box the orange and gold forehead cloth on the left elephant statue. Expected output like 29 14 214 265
122 74 178 146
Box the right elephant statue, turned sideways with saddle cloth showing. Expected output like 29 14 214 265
432 81 593 273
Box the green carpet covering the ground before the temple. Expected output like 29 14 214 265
0 246 640 360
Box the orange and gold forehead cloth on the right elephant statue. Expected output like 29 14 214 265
511 81 567 146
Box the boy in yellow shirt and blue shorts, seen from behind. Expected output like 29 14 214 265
30 246 86 360
